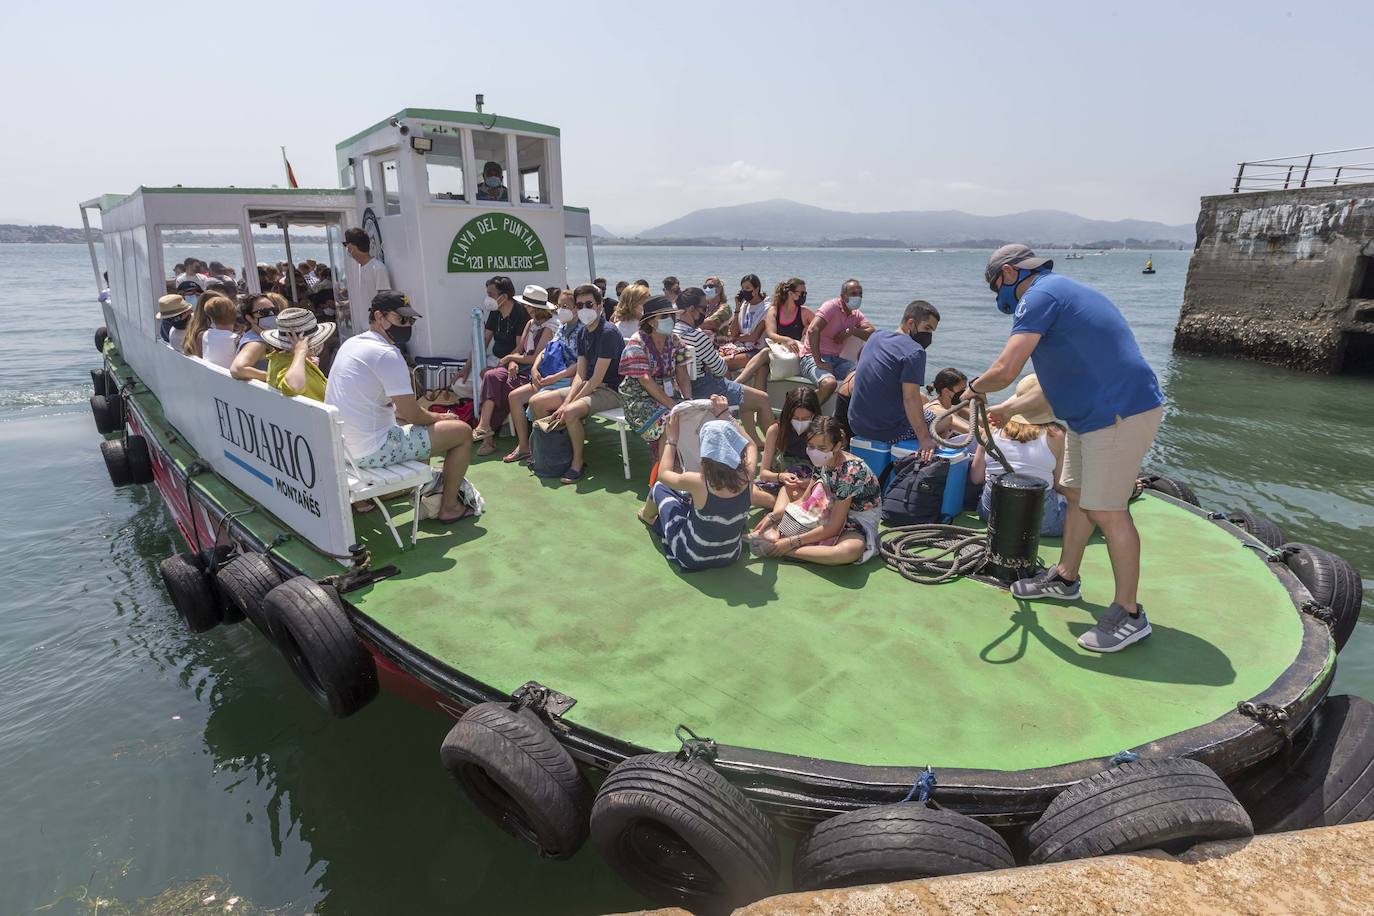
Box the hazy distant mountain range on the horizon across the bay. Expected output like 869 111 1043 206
610 199 1195 247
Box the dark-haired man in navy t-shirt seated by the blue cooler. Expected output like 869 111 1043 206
849 299 940 457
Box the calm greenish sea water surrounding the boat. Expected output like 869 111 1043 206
0 244 1374 913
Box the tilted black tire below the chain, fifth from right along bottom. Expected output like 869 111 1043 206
440 703 592 858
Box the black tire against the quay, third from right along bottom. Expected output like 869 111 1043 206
793 802 1015 890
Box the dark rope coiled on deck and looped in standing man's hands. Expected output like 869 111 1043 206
878 398 1011 585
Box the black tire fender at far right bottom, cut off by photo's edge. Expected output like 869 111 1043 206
1235 695 1374 834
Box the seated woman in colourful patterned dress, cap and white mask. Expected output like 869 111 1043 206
620 295 691 457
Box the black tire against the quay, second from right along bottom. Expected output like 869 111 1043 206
1026 757 1254 865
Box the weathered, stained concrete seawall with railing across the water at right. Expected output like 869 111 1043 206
1173 184 1374 372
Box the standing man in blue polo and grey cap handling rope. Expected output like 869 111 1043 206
965 244 1164 652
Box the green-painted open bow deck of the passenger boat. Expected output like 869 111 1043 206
348 424 1303 770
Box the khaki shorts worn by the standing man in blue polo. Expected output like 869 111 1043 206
1059 407 1164 512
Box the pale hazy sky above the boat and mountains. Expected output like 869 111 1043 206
0 0 1374 232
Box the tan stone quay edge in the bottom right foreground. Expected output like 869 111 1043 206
629 823 1374 916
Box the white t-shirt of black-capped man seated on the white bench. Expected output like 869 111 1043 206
324 331 415 459
